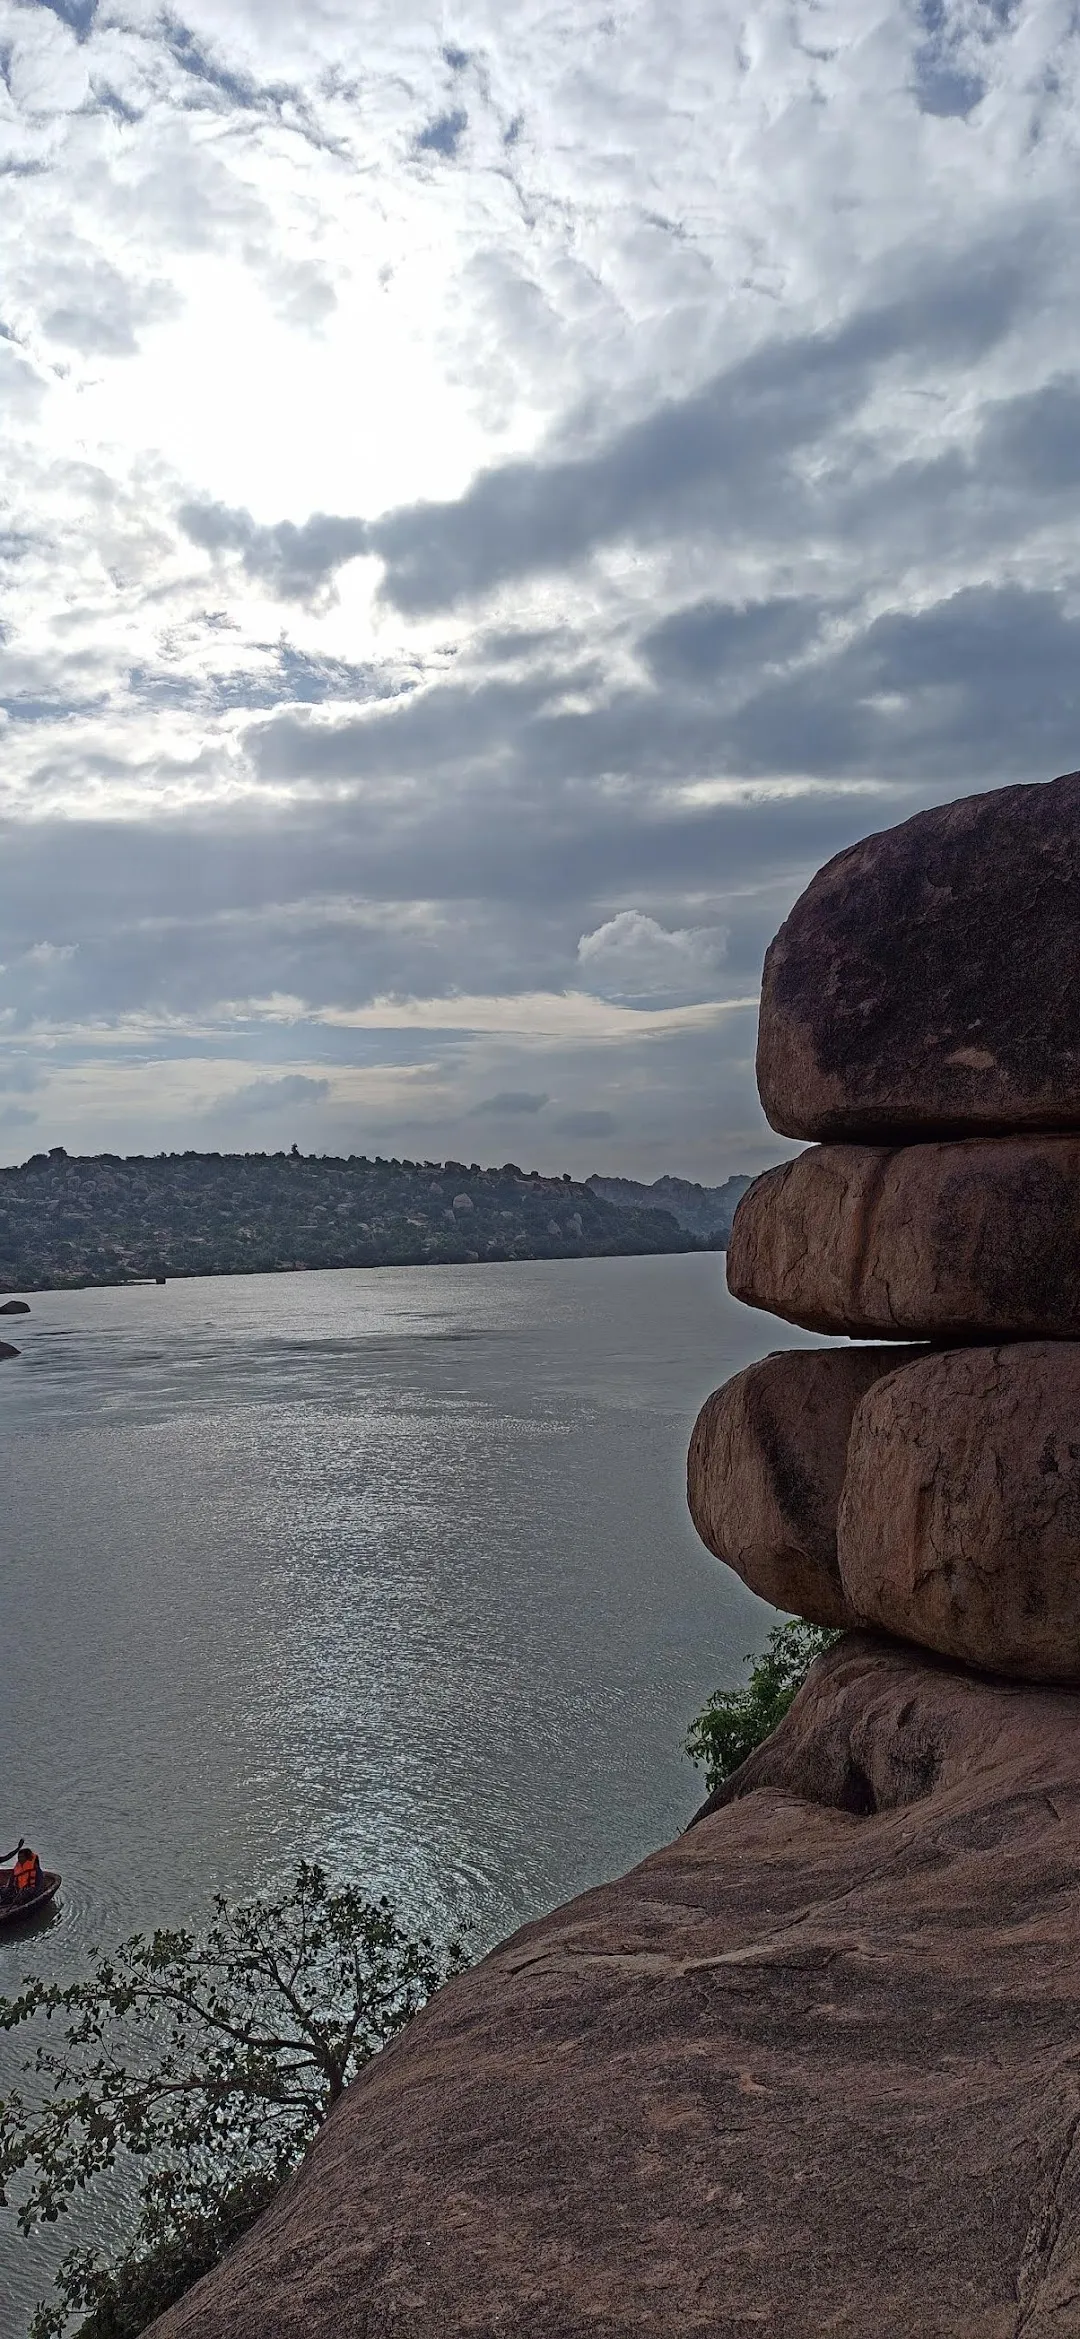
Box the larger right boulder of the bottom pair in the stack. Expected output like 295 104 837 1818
837 1340 1080 1682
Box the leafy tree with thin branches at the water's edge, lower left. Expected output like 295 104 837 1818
0 1862 465 2339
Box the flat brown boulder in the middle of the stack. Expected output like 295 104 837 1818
727 1137 1080 1340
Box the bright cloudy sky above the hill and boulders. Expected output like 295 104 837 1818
0 0 1080 1181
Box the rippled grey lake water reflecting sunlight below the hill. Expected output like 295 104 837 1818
0 1254 802 2339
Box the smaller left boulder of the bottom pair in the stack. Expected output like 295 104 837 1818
687 1347 912 1623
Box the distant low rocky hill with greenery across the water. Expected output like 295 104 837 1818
0 1146 699 1291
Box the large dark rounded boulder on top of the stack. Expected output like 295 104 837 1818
757 772 1080 1141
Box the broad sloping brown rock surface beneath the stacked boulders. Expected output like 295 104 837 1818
154 1635 1080 2339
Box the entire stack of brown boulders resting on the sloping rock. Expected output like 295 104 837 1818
690 772 1080 1684
